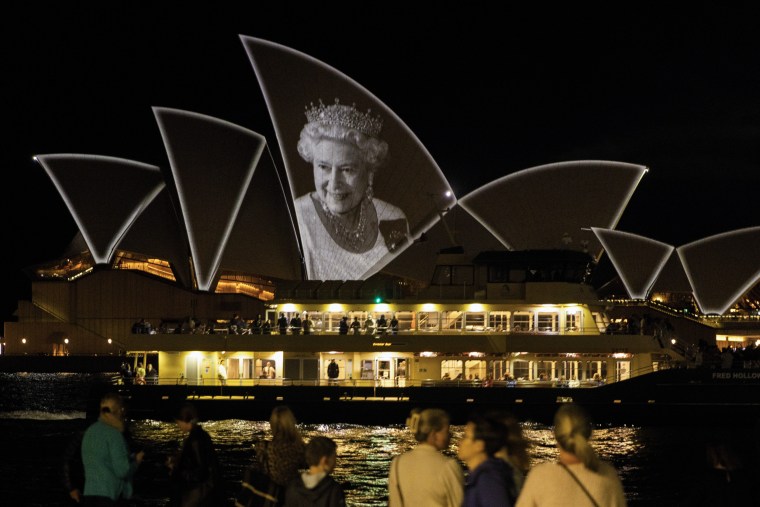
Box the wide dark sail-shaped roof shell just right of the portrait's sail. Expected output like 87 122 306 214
459 160 648 255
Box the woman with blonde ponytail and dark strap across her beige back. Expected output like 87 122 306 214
516 403 627 507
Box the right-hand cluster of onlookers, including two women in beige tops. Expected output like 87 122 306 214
388 404 626 507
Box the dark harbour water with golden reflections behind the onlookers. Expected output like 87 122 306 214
0 373 760 507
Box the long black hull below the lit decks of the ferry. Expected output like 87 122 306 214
110 370 760 426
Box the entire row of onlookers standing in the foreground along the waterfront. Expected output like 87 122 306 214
64 393 648 507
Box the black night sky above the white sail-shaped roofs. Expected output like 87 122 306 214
0 2 760 320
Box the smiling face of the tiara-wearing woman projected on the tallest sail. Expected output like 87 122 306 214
313 139 370 213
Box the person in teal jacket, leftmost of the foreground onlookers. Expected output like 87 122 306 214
82 393 145 506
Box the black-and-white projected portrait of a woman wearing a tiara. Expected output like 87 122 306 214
295 99 409 280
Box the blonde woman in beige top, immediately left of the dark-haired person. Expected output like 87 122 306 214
388 408 464 507
